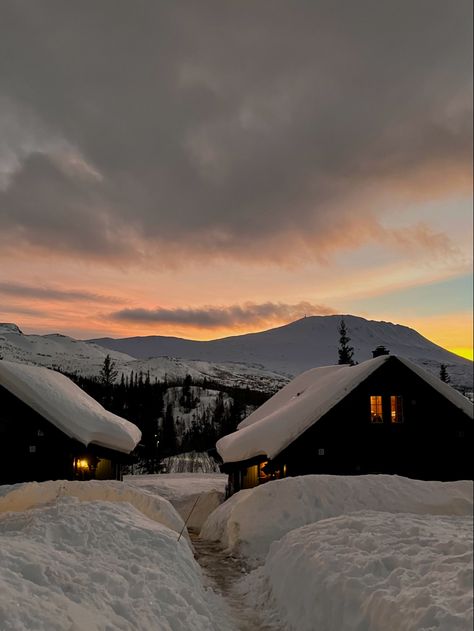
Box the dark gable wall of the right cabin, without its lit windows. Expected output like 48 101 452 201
277 362 472 480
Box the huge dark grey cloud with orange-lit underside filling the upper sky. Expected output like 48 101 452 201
0 0 472 264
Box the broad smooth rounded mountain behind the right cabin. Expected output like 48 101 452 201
90 315 473 388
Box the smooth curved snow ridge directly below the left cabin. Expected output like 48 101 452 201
0 480 183 540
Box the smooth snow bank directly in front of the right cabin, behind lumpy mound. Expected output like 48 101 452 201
201 475 473 560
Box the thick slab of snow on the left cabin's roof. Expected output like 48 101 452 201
0 360 141 453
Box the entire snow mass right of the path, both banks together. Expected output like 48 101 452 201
201 475 473 631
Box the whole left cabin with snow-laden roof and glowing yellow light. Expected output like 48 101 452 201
0 360 141 484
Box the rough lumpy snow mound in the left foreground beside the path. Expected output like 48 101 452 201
0 497 231 631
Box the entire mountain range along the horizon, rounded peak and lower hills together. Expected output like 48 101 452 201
0 314 473 391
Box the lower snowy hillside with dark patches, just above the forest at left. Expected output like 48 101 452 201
0 323 288 392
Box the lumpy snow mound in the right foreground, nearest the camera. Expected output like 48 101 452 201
242 512 473 631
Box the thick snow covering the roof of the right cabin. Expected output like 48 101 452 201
216 355 473 462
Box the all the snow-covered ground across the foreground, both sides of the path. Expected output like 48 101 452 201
0 474 473 631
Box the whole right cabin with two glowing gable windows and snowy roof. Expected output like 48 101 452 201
216 353 473 493
